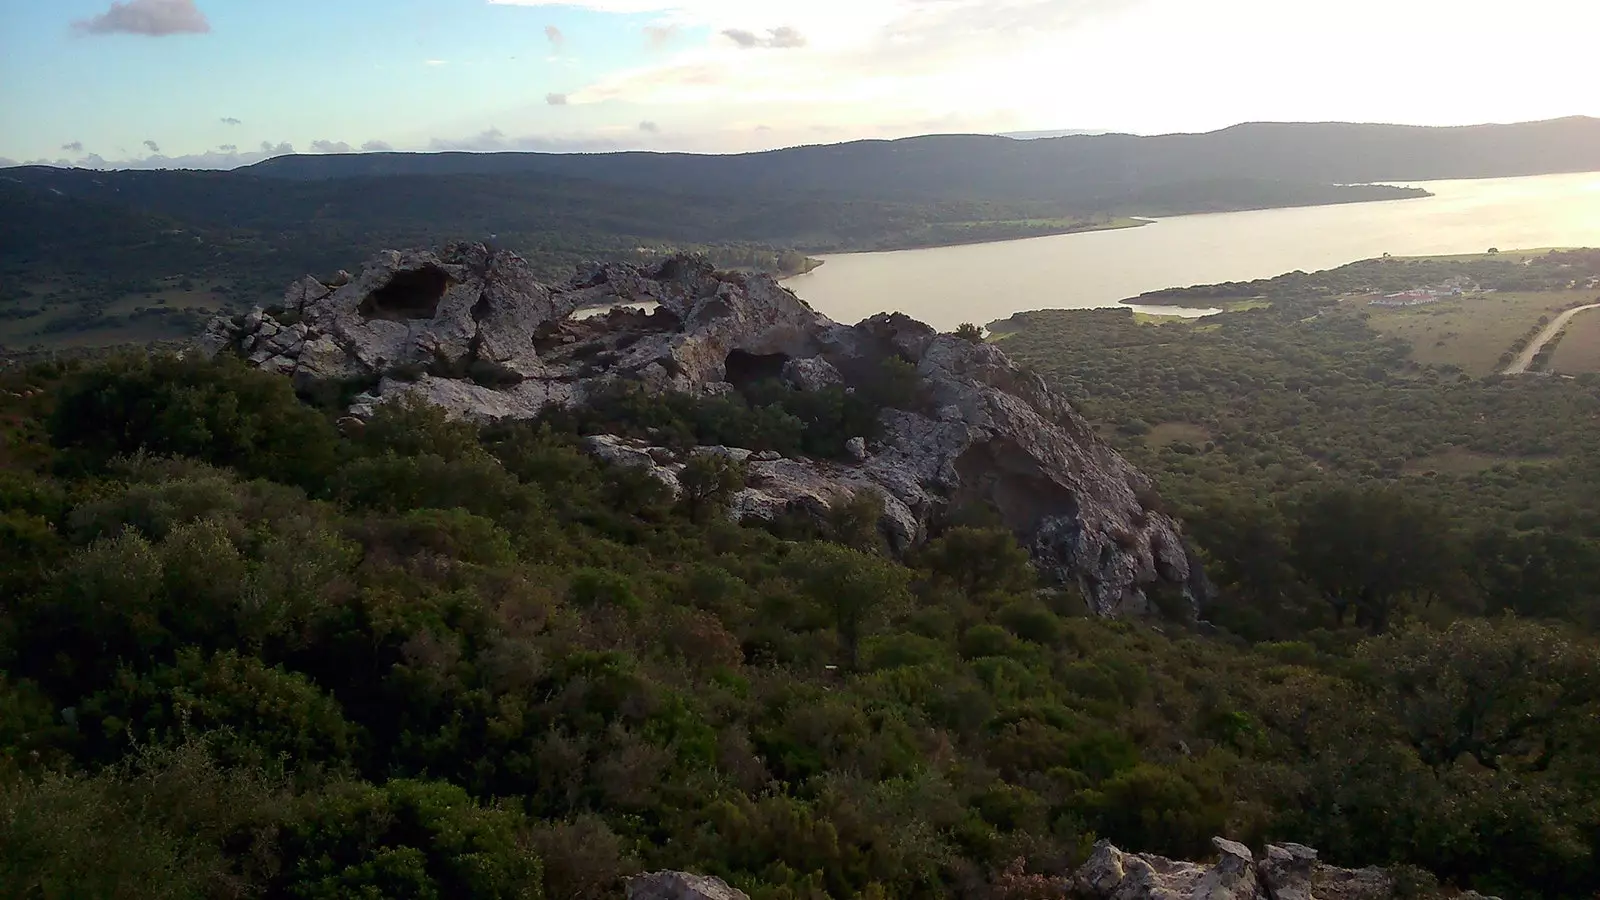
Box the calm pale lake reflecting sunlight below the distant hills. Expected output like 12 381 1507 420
786 173 1600 330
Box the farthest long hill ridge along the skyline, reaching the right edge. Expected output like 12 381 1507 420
246 117 1600 199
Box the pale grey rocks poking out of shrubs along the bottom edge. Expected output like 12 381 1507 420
627 838 1498 900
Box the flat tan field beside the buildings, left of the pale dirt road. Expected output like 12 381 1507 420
1346 291 1594 375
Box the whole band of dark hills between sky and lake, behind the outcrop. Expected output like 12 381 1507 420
15 112 1600 348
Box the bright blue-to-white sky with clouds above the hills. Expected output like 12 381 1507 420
0 0 1600 168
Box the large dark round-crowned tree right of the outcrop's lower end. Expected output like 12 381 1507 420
1291 487 1461 634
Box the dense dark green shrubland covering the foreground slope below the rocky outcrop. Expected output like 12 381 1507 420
0 353 1600 898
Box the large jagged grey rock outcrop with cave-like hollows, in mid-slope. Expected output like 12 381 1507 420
200 243 1205 615
